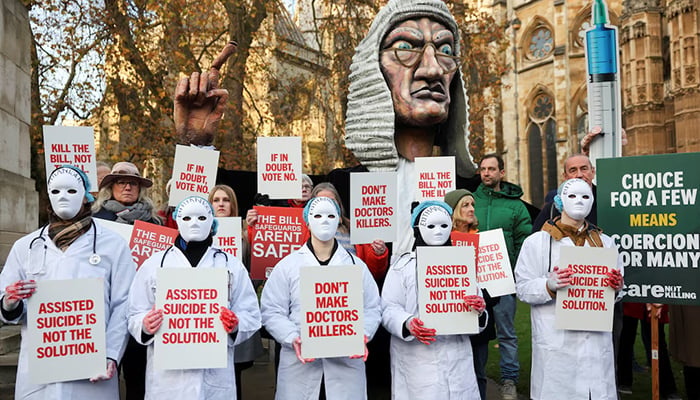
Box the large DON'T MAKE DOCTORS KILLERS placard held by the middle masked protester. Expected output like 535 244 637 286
299 265 365 358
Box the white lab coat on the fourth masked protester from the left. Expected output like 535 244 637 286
382 252 488 400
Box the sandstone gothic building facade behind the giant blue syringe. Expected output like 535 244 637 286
474 0 700 206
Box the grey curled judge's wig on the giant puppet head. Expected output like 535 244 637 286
345 0 476 178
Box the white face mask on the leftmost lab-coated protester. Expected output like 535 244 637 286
47 168 85 220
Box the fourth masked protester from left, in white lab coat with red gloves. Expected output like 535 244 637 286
382 201 488 400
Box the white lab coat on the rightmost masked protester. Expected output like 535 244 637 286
515 231 624 400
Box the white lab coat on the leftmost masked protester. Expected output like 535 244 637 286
0 224 136 399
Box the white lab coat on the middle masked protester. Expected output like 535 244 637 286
261 244 381 400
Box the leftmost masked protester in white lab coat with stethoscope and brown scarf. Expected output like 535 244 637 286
0 166 136 400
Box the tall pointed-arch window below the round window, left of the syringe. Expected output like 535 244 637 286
527 91 558 205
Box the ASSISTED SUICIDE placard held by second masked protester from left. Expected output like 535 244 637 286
153 268 229 369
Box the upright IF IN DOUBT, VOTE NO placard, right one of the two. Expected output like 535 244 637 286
258 136 301 199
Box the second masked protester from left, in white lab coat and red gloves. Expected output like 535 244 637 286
129 197 260 400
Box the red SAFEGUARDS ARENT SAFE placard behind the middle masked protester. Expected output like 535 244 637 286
248 206 308 279
